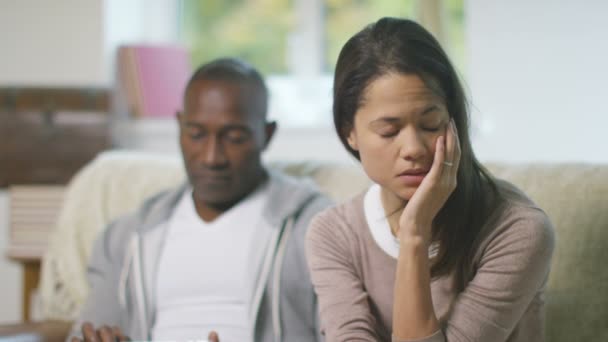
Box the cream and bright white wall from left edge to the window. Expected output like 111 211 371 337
0 0 178 86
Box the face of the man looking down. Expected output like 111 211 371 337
179 80 273 208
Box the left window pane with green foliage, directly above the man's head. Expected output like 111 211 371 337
181 0 294 75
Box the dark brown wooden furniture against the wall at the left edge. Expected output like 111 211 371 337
0 87 110 187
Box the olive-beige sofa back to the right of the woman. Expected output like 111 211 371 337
487 164 608 342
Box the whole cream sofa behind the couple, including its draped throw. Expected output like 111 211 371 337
0 151 608 342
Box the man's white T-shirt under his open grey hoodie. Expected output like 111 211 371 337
152 184 268 342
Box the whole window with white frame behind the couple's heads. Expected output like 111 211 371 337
179 0 465 127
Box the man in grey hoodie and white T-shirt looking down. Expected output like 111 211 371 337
71 59 330 342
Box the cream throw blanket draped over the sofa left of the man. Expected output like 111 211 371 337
39 151 185 320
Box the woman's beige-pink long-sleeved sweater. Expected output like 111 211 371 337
306 181 555 342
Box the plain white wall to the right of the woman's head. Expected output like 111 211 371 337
466 0 608 163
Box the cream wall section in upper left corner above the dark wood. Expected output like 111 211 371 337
0 0 106 86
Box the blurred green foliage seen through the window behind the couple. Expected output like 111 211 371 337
180 0 466 75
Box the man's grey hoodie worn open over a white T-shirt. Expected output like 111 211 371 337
68 171 331 342
